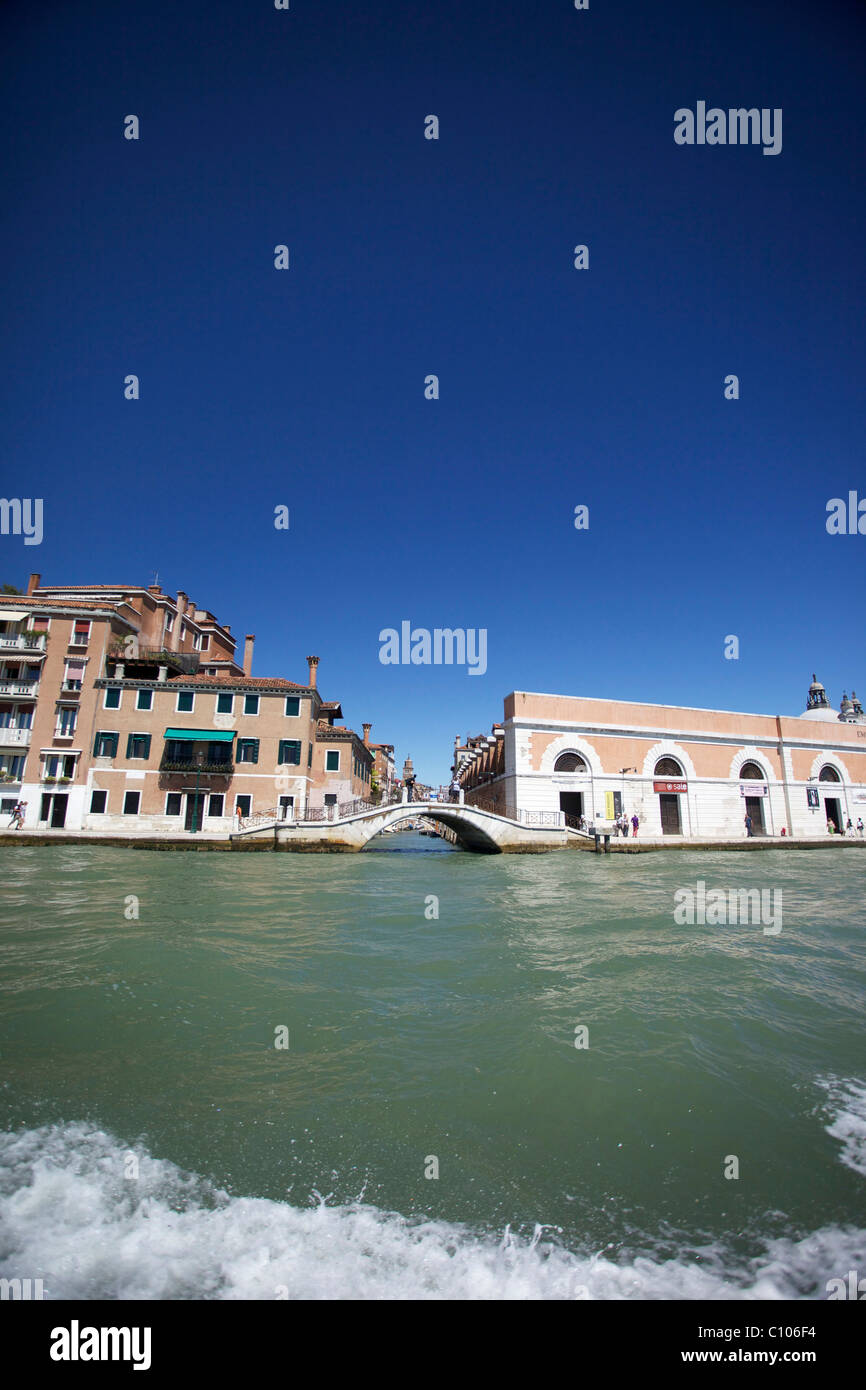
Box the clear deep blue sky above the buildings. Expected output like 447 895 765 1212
0 0 866 780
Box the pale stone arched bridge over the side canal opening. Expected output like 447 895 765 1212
231 801 573 855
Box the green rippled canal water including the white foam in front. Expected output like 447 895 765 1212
0 834 866 1298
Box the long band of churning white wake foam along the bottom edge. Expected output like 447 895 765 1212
0 1123 866 1300
